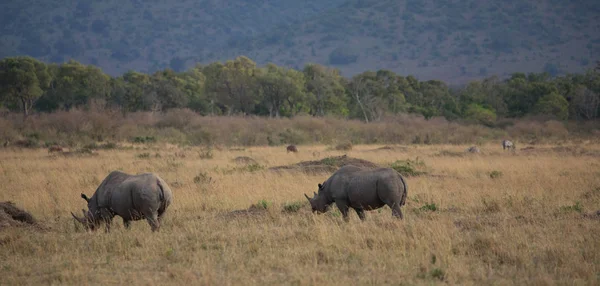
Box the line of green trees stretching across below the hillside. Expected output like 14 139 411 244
0 56 600 125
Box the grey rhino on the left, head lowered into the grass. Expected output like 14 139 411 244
71 171 173 232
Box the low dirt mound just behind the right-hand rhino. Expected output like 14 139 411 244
269 155 379 174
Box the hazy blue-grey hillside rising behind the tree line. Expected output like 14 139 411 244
0 0 600 83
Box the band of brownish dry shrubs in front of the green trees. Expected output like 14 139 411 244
0 108 598 146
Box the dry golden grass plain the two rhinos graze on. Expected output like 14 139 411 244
0 144 600 285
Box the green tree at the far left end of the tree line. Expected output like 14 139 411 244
0 57 51 117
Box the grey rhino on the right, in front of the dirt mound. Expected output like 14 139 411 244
304 165 408 221
